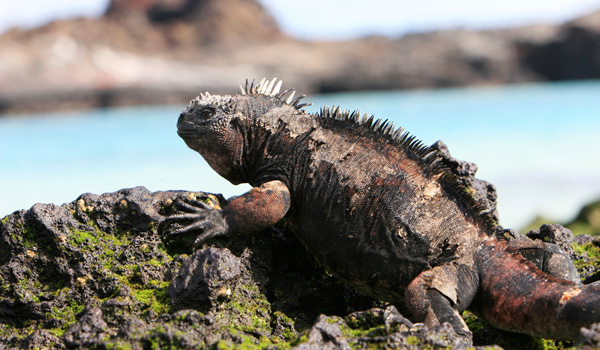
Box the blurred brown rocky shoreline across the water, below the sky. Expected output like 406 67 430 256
0 0 600 113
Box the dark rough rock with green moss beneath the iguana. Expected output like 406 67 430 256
0 187 597 349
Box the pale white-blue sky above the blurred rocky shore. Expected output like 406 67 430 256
0 0 600 40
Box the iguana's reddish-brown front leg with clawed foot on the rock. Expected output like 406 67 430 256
162 180 290 247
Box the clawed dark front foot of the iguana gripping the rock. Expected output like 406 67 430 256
159 200 228 249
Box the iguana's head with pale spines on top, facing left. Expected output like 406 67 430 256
177 78 307 184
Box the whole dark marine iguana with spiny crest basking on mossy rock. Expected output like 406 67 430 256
163 79 600 339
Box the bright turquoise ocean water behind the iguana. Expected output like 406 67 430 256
0 81 600 229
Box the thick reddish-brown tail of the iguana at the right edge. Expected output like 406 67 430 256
471 242 600 340
